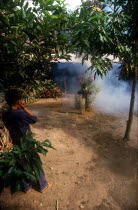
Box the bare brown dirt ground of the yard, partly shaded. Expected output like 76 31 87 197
0 98 138 210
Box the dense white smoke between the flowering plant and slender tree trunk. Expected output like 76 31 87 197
94 64 138 114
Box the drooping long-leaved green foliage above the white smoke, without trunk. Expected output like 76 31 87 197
69 0 136 76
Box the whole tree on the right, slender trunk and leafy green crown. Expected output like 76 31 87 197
69 0 138 141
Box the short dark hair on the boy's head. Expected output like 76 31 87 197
5 89 22 106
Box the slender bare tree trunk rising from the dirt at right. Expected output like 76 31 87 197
123 67 137 141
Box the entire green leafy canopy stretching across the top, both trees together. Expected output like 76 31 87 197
0 0 138 89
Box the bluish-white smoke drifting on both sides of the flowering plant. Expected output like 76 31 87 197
53 59 138 114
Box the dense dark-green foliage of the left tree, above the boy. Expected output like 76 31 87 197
0 0 69 93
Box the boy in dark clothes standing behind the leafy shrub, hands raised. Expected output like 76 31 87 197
2 89 48 193
